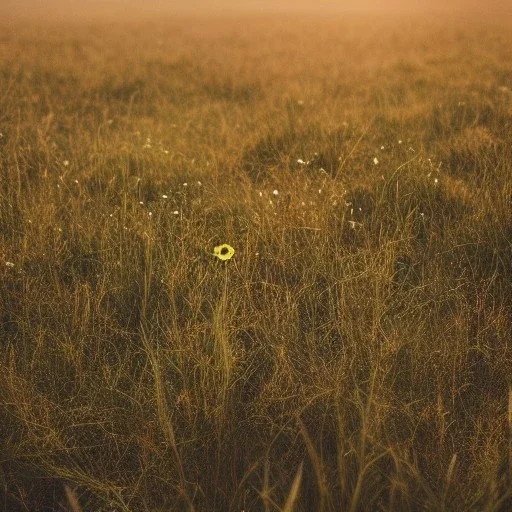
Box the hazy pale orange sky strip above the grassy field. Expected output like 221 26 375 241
0 0 512 20
